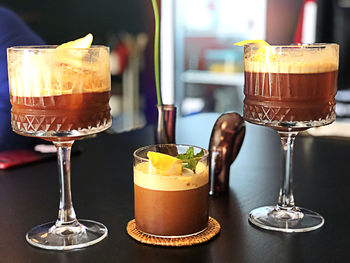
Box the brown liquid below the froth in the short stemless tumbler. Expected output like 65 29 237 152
134 184 209 236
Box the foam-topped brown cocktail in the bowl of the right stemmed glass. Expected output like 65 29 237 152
244 46 338 130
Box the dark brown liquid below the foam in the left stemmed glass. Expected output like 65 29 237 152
11 91 111 138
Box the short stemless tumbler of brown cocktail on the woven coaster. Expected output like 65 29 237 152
134 144 209 238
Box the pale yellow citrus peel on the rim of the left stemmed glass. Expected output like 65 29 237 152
56 33 93 68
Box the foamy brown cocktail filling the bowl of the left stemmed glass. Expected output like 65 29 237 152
8 44 111 141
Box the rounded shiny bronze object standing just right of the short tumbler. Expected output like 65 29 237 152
209 112 245 195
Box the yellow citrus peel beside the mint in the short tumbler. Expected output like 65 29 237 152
147 151 182 176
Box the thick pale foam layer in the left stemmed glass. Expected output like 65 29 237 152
8 48 111 97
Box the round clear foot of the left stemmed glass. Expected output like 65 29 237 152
26 220 108 250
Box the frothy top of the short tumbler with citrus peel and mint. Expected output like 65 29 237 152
134 144 209 191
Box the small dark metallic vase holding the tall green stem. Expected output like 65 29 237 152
155 104 176 144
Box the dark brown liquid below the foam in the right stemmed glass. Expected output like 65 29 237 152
244 71 338 129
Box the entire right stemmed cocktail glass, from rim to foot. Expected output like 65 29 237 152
244 44 339 232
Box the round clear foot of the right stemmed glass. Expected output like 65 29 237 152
248 206 324 233
